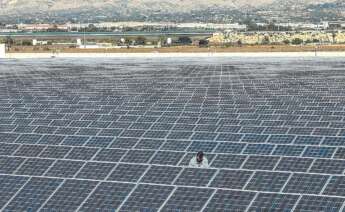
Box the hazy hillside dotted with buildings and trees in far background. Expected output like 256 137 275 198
0 0 345 22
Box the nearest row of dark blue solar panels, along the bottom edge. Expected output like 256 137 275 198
0 173 345 211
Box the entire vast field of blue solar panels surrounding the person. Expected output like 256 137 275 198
0 58 345 211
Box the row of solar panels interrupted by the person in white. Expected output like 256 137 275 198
0 143 345 174
